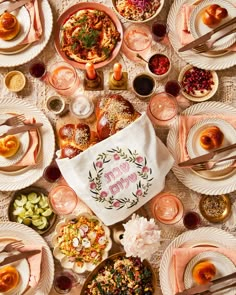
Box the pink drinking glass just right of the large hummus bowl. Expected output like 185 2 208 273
122 24 152 62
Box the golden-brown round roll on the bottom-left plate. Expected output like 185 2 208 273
0 266 20 292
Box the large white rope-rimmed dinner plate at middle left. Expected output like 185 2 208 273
0 98 55 191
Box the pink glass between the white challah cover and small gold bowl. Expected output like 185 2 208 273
151 192 184 224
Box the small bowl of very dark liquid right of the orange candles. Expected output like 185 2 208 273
132 73 156 99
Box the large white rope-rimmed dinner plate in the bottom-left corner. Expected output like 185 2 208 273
0 222 54 295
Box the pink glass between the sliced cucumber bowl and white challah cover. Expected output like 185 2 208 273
48 185 78 215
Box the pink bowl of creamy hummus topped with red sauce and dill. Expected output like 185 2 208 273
55 2 123 69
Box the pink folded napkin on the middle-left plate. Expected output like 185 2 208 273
14 119 39 166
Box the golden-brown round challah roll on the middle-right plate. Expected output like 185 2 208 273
200 126 224 150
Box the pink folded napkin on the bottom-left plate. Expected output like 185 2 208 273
19 245 43 288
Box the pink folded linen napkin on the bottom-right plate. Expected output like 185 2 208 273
173 247 236 293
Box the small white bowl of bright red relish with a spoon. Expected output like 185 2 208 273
147 53 171 80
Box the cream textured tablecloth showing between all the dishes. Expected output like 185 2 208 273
0 0 236 295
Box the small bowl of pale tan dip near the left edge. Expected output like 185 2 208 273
4 71 26 92
